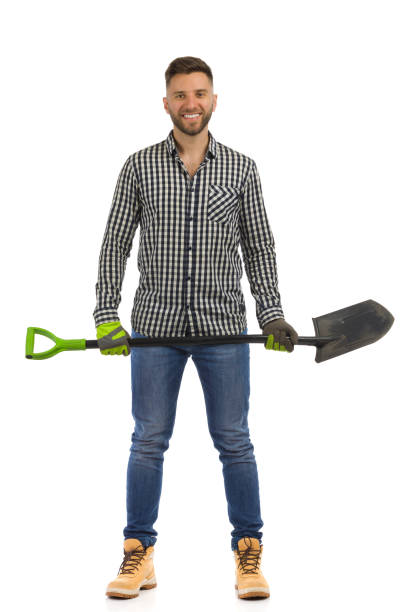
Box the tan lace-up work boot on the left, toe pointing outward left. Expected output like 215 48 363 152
106 538 157 599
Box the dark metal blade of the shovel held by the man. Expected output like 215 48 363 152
313 300 394 363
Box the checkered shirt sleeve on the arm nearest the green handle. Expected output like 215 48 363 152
93 156 140 327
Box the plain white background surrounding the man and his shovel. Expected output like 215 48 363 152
0 0 408 612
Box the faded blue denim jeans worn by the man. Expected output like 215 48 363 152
123 329 263 550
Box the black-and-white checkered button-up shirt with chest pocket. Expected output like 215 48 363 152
93 130 284 337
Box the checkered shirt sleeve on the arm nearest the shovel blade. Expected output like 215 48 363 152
239 160 284 329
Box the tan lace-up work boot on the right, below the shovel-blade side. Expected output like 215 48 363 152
234 537 269 599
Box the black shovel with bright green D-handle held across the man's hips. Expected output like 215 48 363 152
26 300 394 363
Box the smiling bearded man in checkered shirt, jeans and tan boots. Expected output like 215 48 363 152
94 57 297 598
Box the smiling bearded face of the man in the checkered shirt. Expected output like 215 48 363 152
163 72 217 136
